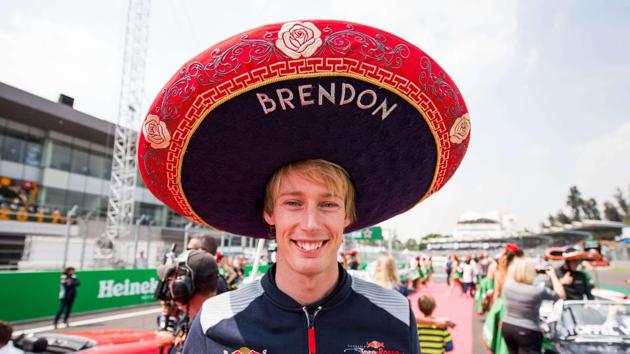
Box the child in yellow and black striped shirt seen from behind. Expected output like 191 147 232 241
418 295 453 354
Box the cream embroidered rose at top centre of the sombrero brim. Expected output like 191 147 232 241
276 22 322 59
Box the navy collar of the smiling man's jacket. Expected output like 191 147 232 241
261 264 352 311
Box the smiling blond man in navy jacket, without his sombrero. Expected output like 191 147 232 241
185 160 418 353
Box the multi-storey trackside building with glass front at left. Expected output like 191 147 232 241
0 82 241 269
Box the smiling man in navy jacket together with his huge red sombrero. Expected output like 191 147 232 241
138 20 470 354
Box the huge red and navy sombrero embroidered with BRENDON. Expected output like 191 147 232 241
138 20 470 237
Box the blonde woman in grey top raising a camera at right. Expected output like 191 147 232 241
502 257 566 354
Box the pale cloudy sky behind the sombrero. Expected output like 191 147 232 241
0 0 630 239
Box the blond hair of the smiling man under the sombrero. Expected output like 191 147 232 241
264 159 356 224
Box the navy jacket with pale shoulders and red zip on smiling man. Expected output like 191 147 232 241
184 266 419 354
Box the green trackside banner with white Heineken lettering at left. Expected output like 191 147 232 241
0 268 158 321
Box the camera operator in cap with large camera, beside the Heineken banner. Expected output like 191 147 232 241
158 250 218 353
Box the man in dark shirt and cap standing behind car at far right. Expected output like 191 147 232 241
556 247 595 300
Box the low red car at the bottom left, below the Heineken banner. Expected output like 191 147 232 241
13 329 168 354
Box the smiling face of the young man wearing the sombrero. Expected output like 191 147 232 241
264 173 350 276
